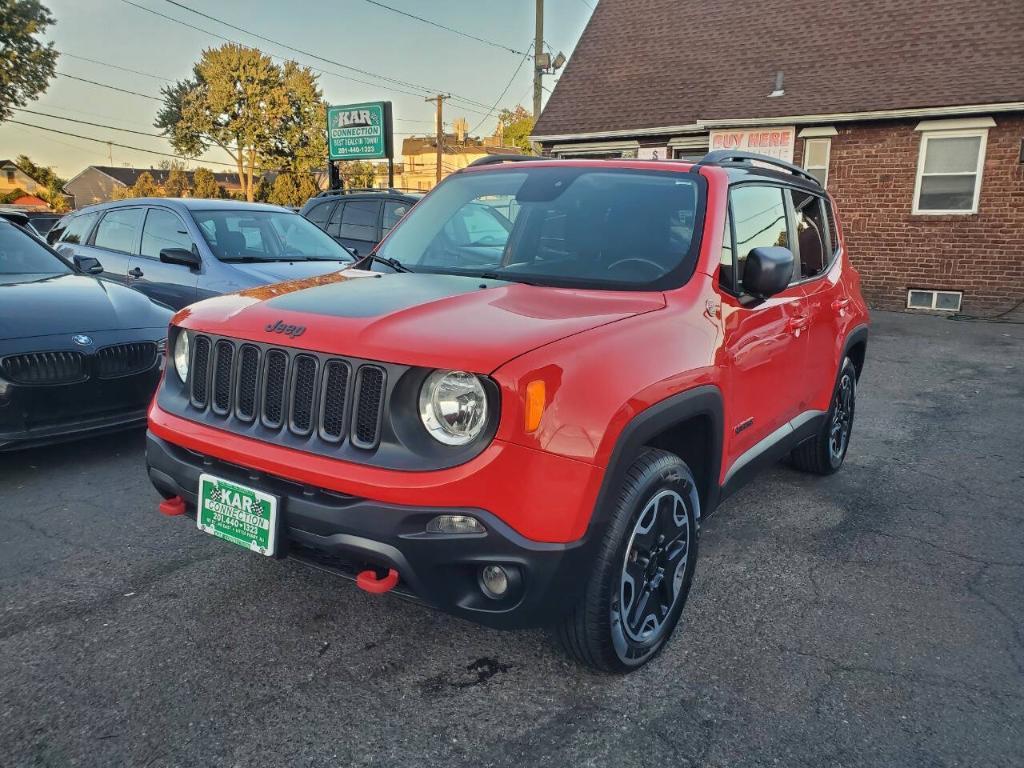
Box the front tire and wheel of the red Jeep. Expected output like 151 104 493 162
556 449 700 673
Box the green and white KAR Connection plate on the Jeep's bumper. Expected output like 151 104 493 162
196 474 278 555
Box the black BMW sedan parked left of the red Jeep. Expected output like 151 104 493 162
0 220 172 451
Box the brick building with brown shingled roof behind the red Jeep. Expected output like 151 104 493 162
532 0 1024 314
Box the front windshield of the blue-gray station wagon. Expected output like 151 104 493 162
191 209 354 262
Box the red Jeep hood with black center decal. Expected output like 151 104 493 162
174 269 665 373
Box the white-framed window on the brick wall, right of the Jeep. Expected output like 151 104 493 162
913 130 988 214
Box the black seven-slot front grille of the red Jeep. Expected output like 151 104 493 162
187 335 387 451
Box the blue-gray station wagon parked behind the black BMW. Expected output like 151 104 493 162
48 198 353 309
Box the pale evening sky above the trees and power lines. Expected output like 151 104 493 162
0 0 597 178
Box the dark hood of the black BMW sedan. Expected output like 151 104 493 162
0 274 171 341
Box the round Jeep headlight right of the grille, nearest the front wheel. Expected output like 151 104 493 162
420 371 487 445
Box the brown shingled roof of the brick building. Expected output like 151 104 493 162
534 0 1024 136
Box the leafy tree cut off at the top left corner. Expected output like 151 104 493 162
0 0 57 121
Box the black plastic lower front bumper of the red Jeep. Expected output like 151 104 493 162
146 432 593 629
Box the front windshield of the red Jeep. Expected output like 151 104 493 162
377 165 703 290
